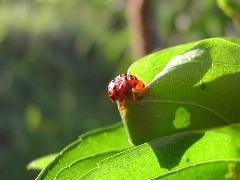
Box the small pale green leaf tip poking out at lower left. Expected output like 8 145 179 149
27 153 58 170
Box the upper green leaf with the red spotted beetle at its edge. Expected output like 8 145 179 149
121 38 240 145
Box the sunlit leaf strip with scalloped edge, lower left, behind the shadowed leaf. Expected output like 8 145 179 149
37 123 131 179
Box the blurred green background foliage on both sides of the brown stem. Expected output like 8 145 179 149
0 0 239 179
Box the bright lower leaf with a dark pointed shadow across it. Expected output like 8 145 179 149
82 132 240 179
